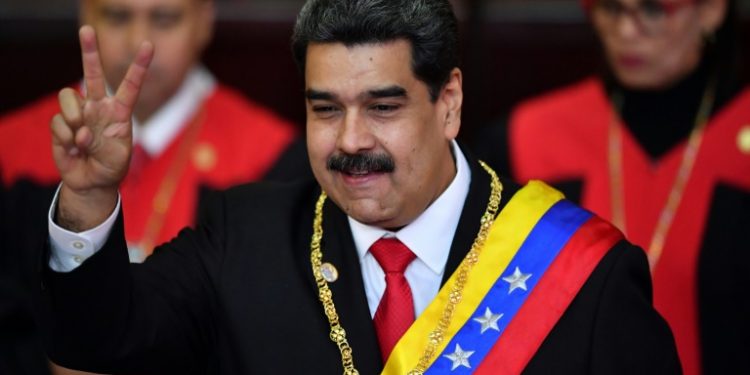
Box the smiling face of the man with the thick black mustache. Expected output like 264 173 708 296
305 40 462 228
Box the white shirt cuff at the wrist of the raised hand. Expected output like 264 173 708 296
47 183 120 272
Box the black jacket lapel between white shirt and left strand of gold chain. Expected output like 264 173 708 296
322 200 383 374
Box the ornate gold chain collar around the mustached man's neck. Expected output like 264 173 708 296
310 161 503 375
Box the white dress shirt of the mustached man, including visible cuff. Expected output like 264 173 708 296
49 141 471 316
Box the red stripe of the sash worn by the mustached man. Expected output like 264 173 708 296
475 216 623 375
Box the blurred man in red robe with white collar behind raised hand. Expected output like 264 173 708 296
0 0 306 374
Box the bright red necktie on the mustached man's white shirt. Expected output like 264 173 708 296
370 238 416 362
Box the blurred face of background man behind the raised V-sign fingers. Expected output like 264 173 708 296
81 0 214 121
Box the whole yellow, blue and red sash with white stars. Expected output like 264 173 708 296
383 181 622 374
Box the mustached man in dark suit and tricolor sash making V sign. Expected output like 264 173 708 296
36 0 680 374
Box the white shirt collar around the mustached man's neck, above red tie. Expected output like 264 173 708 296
349 141 471 274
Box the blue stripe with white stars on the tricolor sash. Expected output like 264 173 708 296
425 200 591 374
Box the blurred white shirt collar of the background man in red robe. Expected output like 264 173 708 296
133 67 216 157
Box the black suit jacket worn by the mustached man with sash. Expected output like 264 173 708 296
36 161 680 375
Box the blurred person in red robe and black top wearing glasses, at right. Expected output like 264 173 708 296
478 0 750 375
